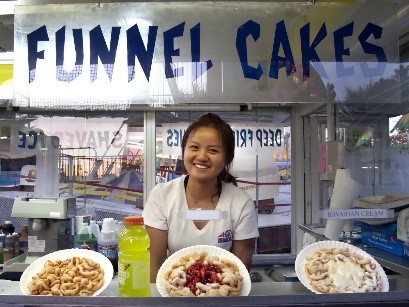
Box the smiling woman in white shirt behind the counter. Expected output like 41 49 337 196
143 113 258 281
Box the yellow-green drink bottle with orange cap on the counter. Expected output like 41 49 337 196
118 216 150 297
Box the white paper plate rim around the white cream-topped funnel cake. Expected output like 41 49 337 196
295 241 389 294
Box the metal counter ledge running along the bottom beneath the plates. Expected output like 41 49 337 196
0 277 409 306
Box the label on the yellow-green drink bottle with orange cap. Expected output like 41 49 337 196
118 260 150 289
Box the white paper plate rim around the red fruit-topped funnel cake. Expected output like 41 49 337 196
156 245 251 297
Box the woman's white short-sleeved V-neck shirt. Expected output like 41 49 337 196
142 175 259 254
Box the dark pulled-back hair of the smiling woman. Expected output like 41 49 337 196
182 113 237 195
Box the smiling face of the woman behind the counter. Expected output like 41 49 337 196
183 127 226 181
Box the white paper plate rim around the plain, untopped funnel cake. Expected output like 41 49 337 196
20 248 114 296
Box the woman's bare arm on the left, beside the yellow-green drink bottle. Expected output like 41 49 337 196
145 226 168 283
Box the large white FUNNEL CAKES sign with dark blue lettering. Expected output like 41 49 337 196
14 1 399 109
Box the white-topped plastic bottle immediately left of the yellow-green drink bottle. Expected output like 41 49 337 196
97 218 118 272
